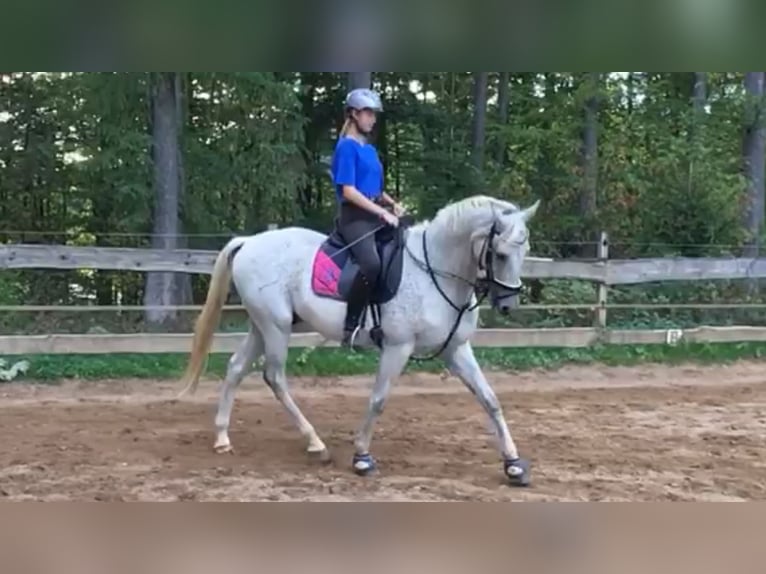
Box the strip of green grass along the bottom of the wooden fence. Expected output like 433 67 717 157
5 342 766 388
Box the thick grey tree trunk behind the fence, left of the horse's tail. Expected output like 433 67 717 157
144 72 181 325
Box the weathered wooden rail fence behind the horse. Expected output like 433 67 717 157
0 235 766 355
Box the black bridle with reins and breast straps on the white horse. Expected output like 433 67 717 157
405 222 521 361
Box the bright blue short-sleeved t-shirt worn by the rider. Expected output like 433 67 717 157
332 137 383 200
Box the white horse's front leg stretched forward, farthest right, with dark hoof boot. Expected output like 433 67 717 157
445 341 529 486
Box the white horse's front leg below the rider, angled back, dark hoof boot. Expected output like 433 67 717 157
354 343 414 476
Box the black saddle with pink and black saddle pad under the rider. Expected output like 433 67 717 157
311 215 414 305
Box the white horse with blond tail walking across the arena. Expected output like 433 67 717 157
179 195 540 486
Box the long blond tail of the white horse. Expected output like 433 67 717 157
178 237 245 398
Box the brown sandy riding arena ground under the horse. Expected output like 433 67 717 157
0 362 766 501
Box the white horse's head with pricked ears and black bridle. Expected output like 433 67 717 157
471 200 540 315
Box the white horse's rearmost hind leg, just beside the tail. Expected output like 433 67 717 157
214 323 263 454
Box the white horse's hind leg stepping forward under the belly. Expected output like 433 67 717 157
261 322 330 462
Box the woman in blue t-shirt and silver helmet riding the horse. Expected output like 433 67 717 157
332 89 403 347
